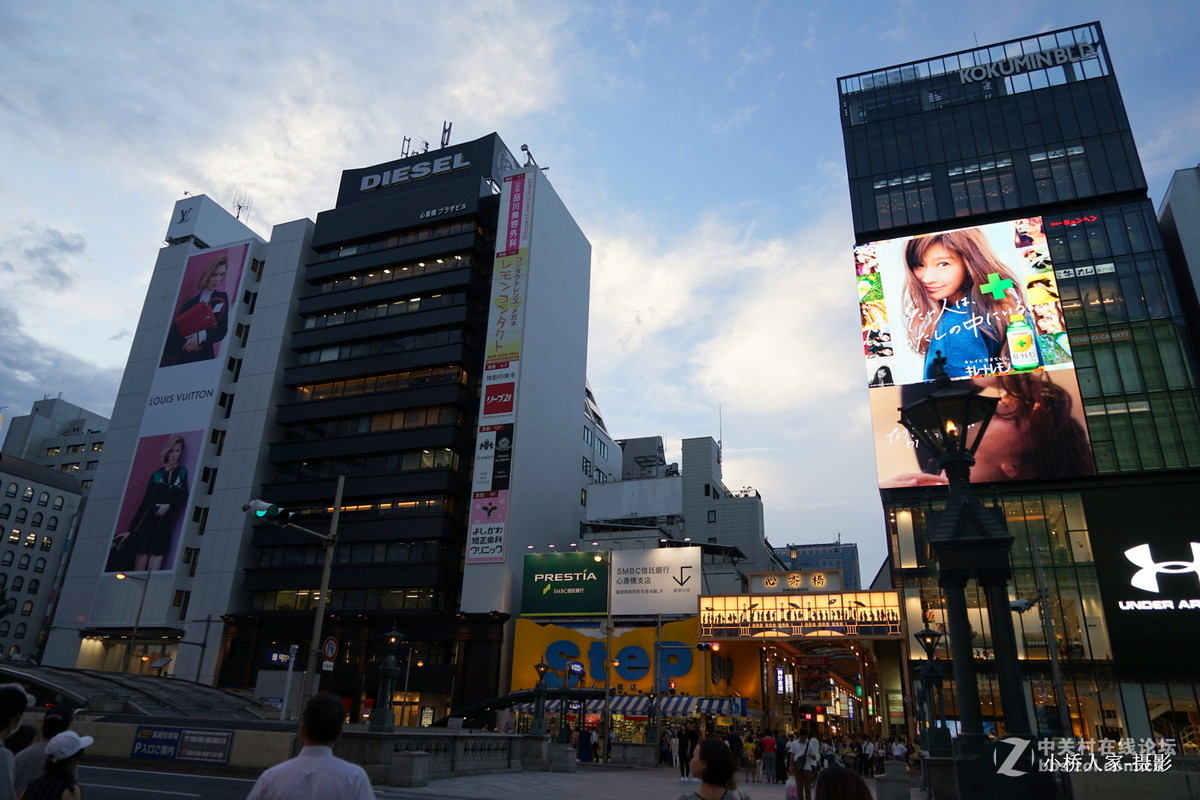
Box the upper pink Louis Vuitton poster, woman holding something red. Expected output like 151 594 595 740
158 245 247 367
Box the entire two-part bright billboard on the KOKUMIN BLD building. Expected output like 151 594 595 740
854 217 1096 488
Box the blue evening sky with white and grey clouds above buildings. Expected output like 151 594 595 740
0 0 1200 582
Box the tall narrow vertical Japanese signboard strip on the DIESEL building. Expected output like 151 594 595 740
467 172 534 564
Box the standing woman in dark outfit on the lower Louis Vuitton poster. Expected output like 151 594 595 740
109 435 187 572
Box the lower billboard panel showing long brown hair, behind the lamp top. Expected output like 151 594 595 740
869 369 1096 488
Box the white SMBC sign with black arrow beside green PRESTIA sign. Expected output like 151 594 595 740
611 547 701 614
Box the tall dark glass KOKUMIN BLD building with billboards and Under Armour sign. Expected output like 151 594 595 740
839 23 1200 754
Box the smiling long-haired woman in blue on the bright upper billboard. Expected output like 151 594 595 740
904 228 1037 380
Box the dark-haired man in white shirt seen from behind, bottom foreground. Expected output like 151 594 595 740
246 693 374 800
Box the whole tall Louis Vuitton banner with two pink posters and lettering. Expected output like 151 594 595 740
104 245 250 572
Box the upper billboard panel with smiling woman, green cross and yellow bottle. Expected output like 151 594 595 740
854 217 1072 387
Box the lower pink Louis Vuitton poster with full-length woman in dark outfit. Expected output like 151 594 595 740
104 431 204 572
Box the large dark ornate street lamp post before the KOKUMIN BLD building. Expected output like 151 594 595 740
900 351 1039 798
